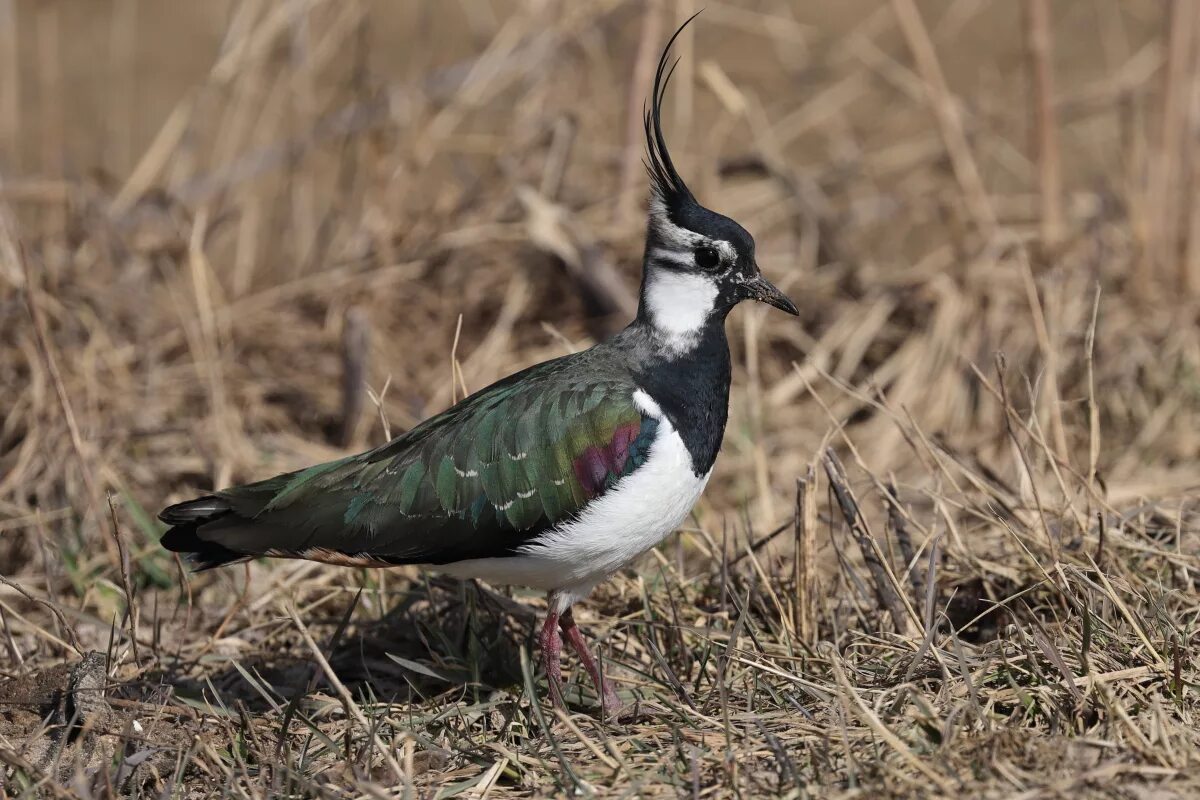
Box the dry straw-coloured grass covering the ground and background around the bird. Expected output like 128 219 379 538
0 0 1200 800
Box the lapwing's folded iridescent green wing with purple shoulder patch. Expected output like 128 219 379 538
197 362 658 564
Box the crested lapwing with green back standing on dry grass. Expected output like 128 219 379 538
160 18 799 718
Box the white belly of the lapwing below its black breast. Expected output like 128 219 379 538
439 392 712 600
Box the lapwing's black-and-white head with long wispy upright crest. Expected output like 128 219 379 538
638 19 799 347
